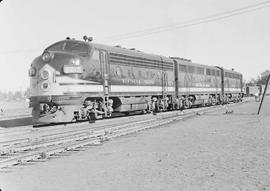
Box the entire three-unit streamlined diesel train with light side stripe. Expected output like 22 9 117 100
29 38 242 125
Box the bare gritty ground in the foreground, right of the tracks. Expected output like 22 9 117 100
0 98 270 191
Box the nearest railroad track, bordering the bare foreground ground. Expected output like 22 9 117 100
0 106 223 168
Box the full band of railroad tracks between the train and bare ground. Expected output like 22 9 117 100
0 101 245 169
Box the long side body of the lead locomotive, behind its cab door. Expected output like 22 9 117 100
95 44 174 112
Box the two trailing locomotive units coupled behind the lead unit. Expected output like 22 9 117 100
174 57 243 108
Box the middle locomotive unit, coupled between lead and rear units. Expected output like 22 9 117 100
176 59 221 105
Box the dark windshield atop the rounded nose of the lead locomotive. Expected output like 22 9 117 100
46 41 89 55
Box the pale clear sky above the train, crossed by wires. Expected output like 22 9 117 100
0 0 270 91
